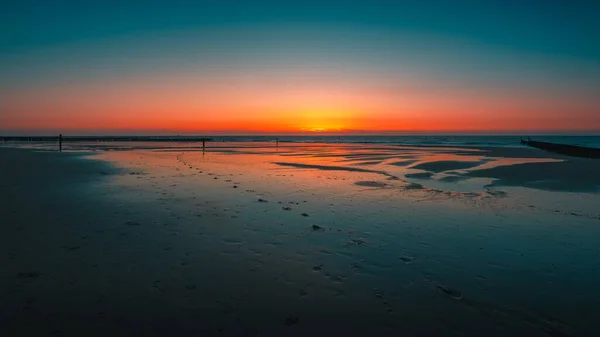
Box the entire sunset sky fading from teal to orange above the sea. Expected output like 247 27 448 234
0 0 600 135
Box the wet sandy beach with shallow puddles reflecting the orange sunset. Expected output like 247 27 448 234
0 142 600 336
